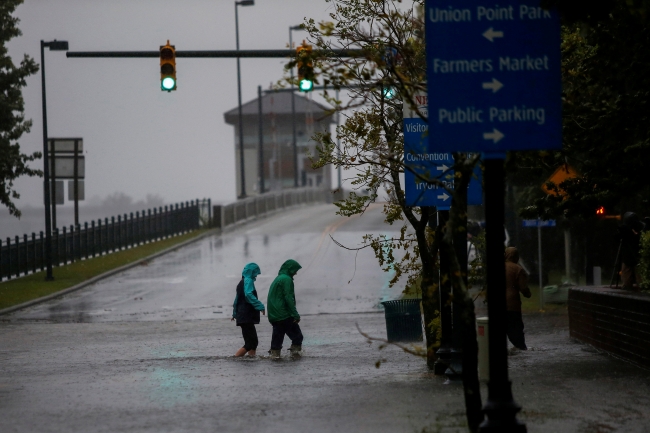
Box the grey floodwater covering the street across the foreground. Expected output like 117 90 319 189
0 308 650 433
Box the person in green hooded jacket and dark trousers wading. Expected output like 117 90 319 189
266 259 303 358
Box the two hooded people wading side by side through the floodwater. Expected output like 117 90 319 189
231 259 303 359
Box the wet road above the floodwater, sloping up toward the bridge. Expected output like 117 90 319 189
12 205 402 322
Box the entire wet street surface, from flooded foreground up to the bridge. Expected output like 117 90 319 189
0 205 650 433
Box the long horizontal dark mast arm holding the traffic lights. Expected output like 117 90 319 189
66 49 366 59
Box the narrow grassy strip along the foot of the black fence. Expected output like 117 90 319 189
0 230 205 309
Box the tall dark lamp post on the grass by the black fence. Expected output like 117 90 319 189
41 39 68 281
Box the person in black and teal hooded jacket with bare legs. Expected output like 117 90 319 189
230 263 265 356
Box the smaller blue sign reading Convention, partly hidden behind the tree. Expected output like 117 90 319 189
403 94 483 210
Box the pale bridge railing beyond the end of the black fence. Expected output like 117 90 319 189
212 188 332 229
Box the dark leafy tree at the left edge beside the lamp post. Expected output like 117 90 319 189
0 0 42 217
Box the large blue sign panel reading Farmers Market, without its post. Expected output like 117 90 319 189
425 0 562 153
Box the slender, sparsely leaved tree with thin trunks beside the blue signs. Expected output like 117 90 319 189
296 0 483 431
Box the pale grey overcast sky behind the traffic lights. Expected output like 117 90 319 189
9 0 331 206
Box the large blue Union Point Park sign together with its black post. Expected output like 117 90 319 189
424 0 562 433
